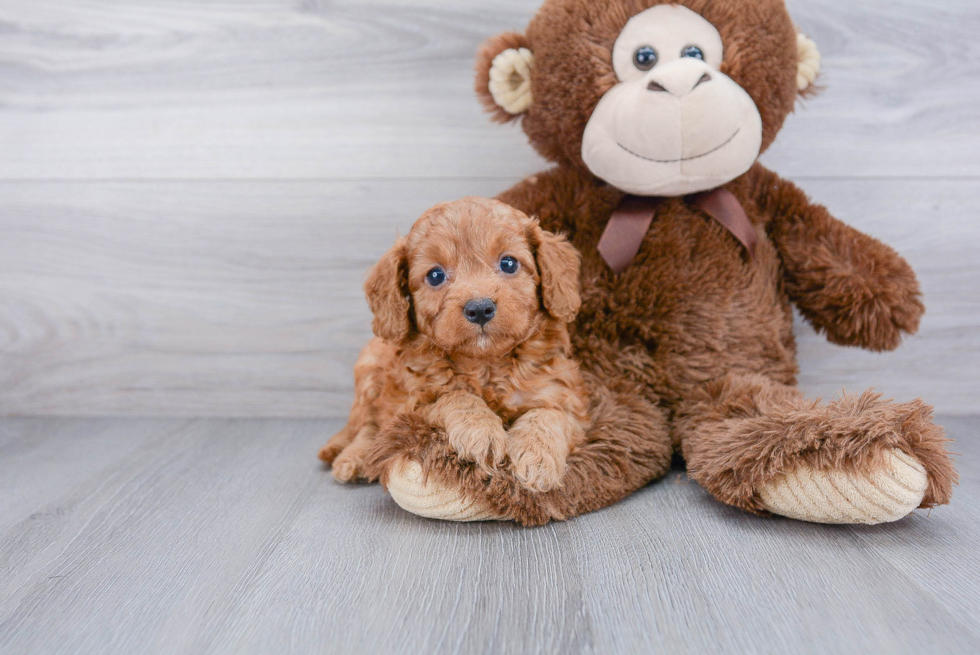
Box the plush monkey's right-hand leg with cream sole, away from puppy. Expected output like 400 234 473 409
674 375 956 524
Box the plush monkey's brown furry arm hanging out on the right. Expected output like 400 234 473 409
753 165 925 351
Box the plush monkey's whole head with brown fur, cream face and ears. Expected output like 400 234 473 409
476 0 820 196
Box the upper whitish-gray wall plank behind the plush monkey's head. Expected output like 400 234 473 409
0 0 980 179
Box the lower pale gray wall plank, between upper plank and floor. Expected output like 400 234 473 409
0 180 980 417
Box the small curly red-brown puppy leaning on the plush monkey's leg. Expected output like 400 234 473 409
320 198 589 491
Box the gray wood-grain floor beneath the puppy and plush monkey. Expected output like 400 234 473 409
0 418 980 655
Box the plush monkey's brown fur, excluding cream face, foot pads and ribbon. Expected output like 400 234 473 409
358 0 956 524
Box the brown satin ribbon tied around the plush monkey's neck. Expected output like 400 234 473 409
598 189 759 273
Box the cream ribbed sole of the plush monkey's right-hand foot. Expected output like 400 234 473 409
759 450 928 525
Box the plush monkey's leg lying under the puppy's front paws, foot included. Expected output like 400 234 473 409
367 375 672 525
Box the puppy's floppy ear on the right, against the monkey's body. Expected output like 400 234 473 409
527 218 582 323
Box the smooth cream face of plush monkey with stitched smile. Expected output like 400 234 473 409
582 5 762 196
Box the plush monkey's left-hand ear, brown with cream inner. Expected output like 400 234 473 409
476 32 534 123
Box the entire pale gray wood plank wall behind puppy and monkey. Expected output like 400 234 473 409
0 0 980 417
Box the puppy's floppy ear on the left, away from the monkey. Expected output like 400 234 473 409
364 239 411 341
